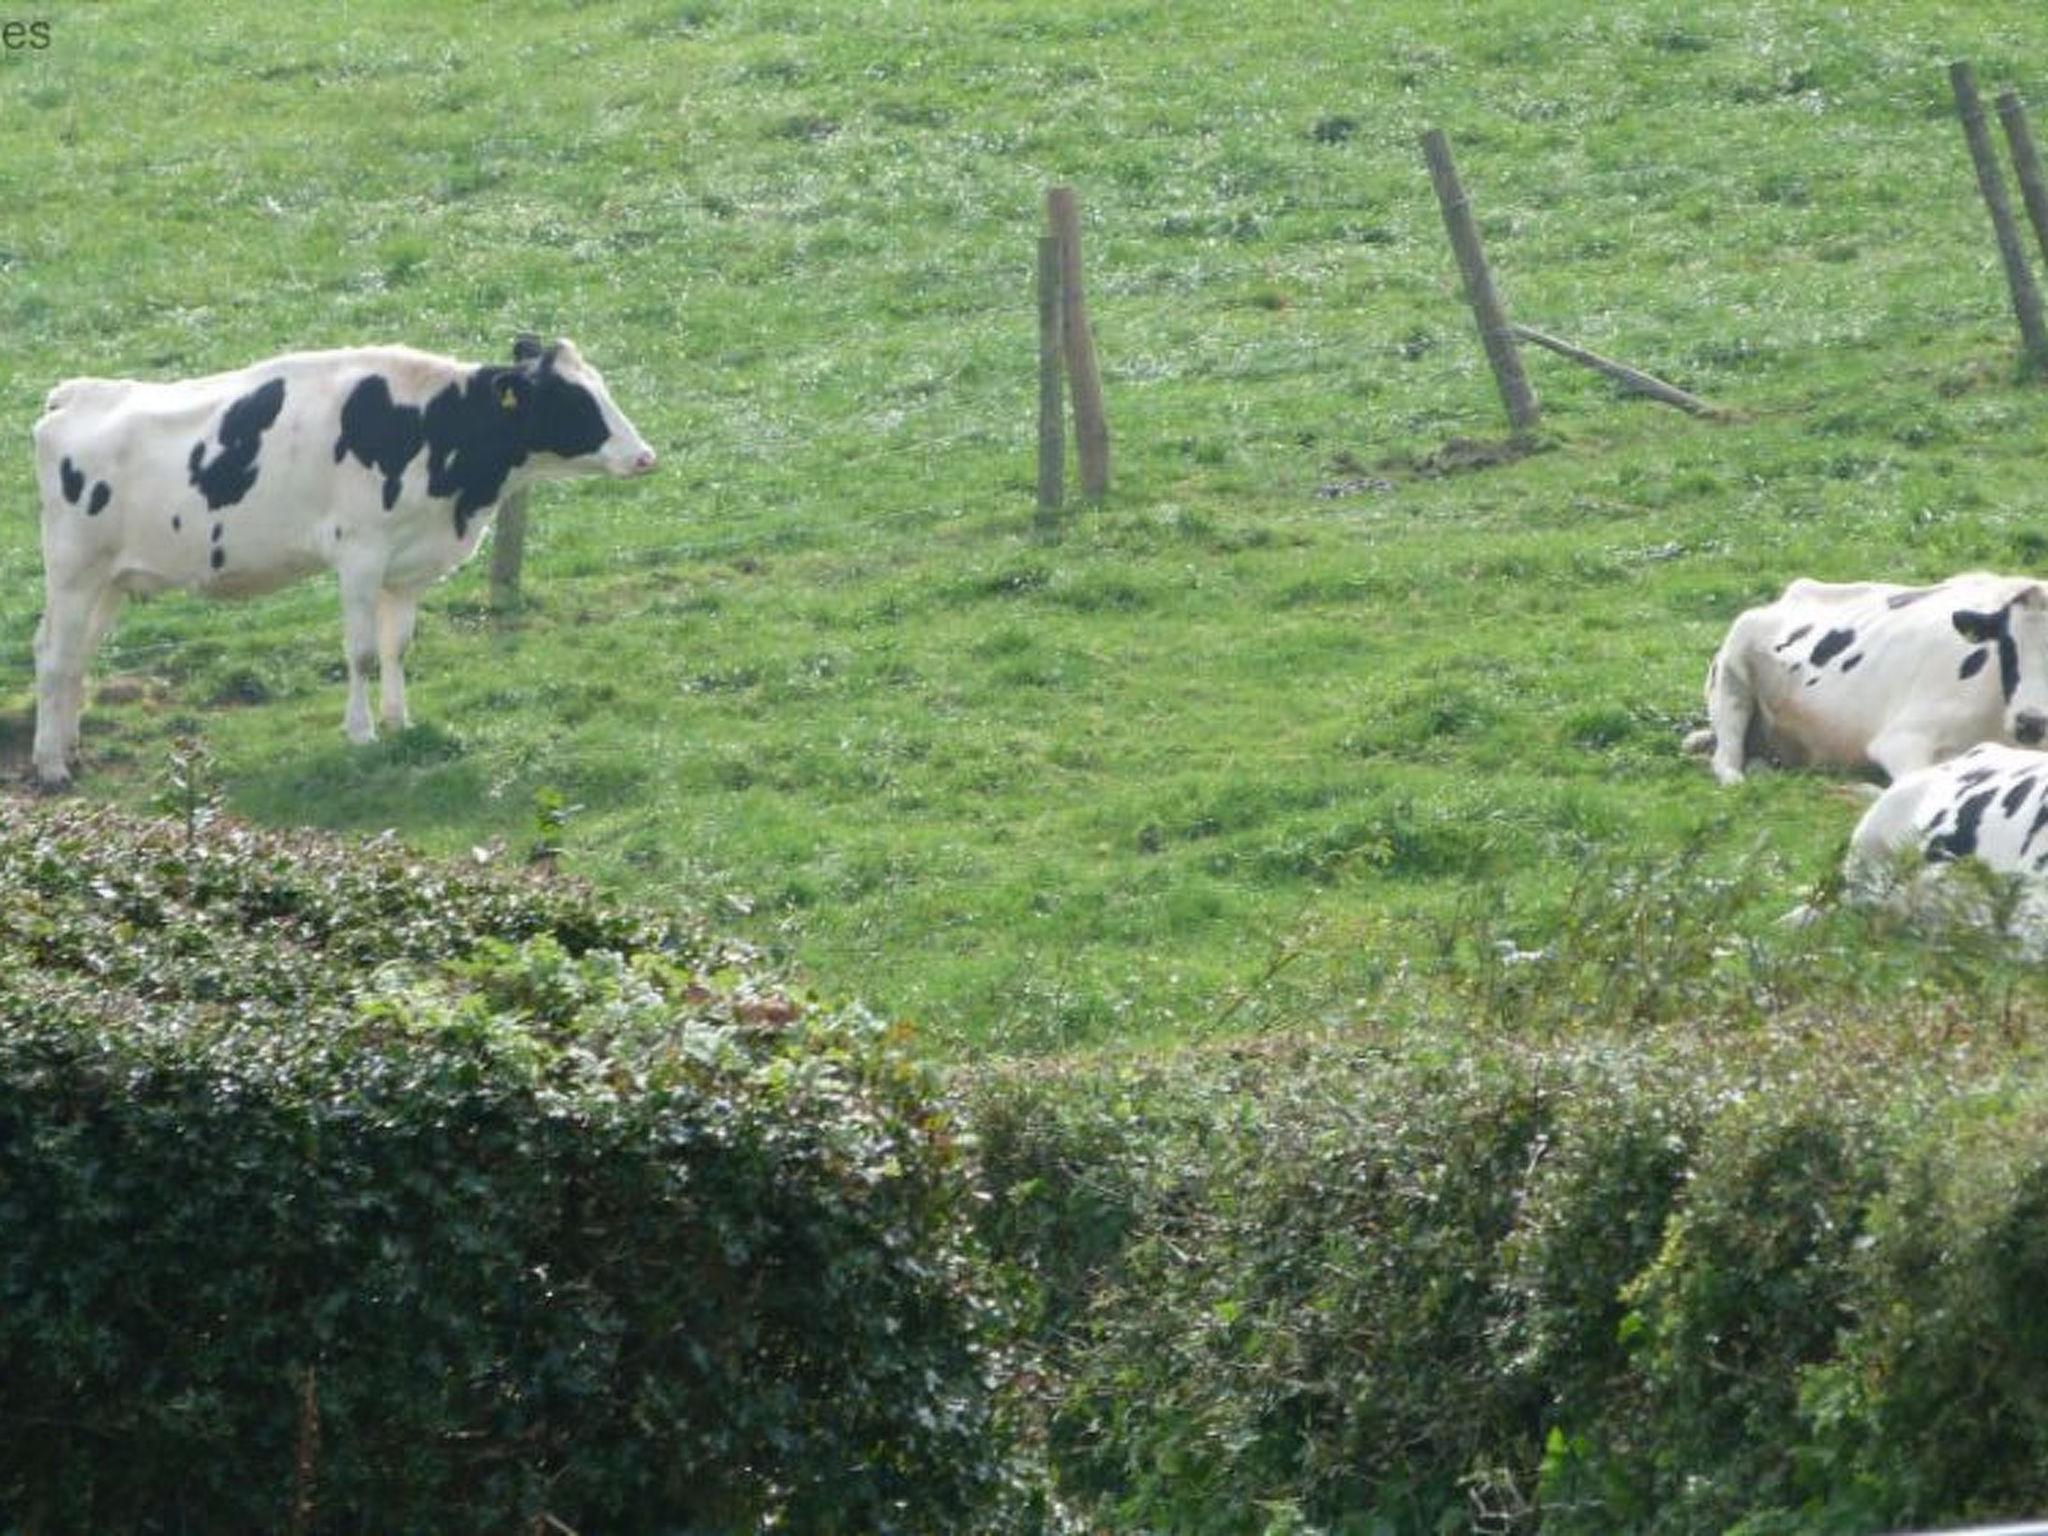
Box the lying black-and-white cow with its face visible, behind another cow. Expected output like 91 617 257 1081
1686 571 2048 784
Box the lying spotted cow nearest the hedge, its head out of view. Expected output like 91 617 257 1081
1826 743 2048 952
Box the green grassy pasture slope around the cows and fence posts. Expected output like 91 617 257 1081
12 0 2048 1053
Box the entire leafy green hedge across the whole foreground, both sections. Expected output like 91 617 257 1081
19 801 2048 1536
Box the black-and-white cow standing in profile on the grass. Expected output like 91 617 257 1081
35 336 655 784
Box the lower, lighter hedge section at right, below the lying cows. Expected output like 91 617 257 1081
975 1024 2048 1536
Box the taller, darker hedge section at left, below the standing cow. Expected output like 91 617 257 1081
0 803 1010 1532
